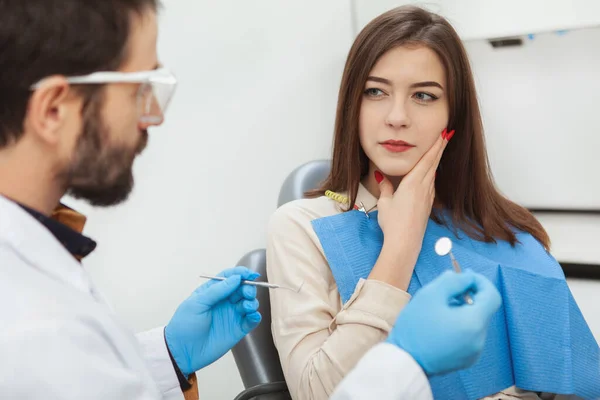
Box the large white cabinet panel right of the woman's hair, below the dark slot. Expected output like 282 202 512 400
466 28 600 210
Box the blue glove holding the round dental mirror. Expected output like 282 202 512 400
387 270 502 376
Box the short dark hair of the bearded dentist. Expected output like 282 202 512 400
0 0 160 148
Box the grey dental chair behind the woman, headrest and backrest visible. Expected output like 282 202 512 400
232 160 330 400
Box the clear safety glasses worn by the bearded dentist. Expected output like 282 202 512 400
31 68 177 125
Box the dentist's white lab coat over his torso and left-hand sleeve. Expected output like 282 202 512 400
0 196 183 400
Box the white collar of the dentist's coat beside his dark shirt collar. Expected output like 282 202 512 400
0 196 94 294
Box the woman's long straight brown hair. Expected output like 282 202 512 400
307 6 550 249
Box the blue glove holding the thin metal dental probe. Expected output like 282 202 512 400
165 267 262 377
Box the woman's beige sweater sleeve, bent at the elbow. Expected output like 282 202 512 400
267 199 410 400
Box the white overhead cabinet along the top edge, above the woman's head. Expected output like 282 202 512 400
352 0 600 40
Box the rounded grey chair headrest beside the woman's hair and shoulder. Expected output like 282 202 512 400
277 160 331 207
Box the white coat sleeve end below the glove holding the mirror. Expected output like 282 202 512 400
330 343 433 400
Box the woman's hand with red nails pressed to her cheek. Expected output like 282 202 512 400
373 131 448 284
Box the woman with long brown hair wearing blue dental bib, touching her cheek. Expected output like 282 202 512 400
267 3 600 400
